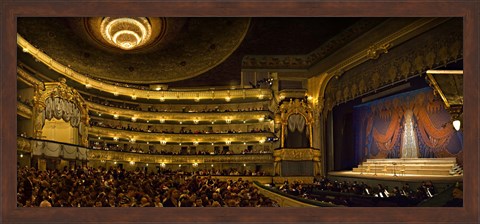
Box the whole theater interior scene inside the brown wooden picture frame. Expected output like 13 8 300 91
16 17 468 207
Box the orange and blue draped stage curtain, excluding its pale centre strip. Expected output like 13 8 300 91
353 87 463 163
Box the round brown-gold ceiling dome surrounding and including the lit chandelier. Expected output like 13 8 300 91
18 17 250 84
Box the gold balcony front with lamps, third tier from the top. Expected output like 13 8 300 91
88 127 274 144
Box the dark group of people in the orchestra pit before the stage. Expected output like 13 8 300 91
279 178 437 206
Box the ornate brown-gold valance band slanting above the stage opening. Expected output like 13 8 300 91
317 18 463 111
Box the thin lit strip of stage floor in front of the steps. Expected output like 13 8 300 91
328 171 463 183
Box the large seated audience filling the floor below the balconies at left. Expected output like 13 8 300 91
17 166 278 207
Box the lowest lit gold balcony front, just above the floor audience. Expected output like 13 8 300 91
88 150 273 164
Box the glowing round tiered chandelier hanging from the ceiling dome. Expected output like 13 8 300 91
100 17 152 50
